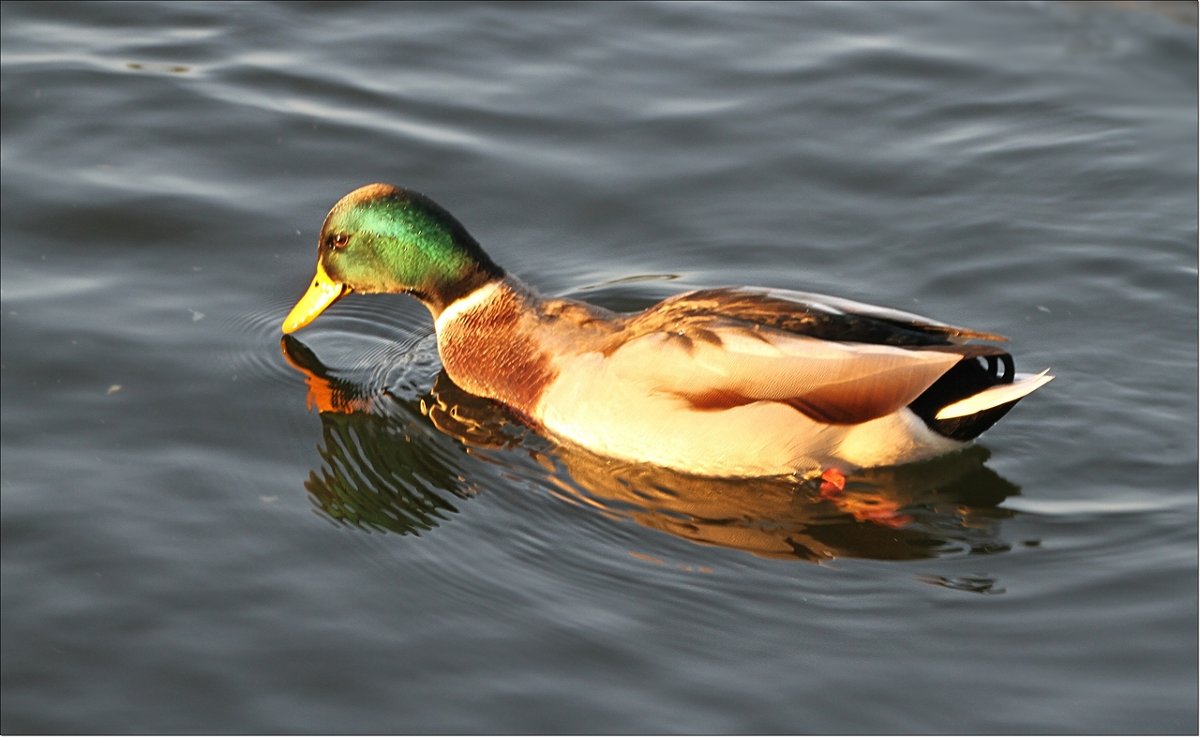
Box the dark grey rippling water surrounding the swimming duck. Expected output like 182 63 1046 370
0 4 1198 733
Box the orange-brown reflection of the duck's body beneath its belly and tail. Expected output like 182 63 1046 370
549 439 1016 561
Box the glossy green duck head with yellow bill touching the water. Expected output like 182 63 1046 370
283 184 504 332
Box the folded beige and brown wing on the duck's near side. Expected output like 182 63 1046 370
608 289 1007 424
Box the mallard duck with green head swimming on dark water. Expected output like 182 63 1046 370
282 184 1054 478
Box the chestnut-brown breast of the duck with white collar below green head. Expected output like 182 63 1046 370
434 276 556 418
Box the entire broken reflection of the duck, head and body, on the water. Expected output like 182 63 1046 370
282 336 1016 561
